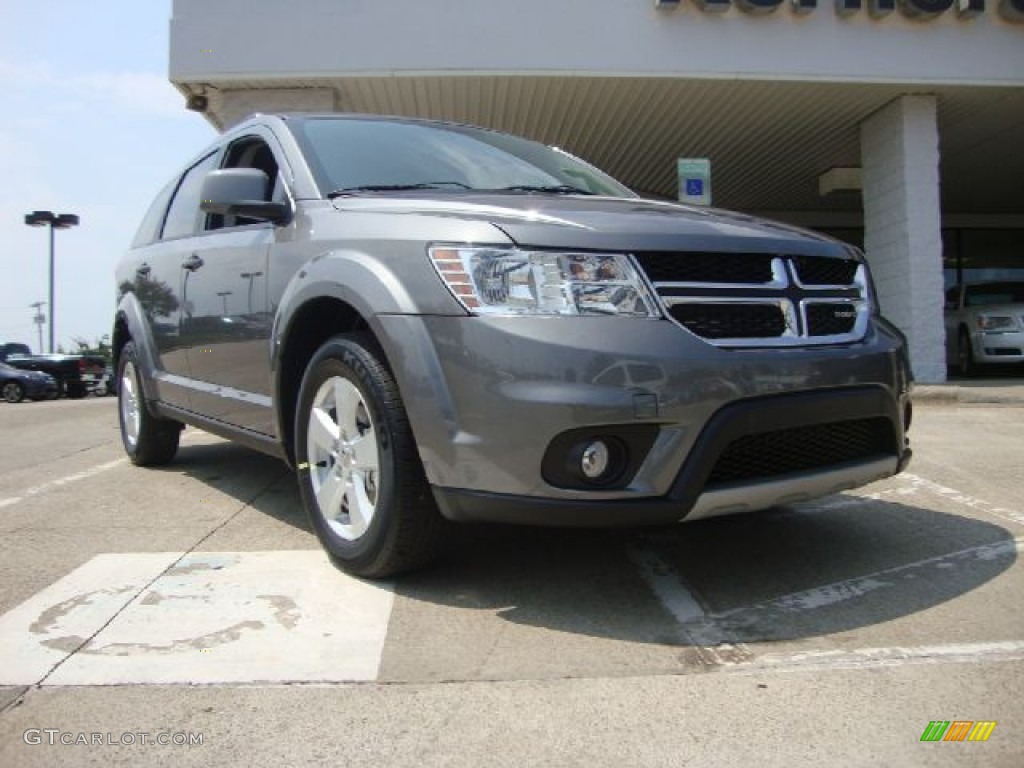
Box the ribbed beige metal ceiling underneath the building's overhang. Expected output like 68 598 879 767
193 76 1024 213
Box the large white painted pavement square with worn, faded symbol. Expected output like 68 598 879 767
0 550 394 685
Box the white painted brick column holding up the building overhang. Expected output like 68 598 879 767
860 95 946 383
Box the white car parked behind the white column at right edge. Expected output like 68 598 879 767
945 282 1024 376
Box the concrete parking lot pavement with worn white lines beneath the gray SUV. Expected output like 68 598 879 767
0 398 1024 766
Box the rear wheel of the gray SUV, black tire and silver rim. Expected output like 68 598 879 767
118 341 182 467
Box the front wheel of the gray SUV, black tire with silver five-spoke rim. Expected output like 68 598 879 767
295 334 447 579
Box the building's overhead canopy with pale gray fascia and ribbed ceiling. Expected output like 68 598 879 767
171 0 1024 214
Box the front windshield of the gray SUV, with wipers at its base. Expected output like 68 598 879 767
292 118 636 198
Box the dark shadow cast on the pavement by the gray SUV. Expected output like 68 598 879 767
157 442 1017 656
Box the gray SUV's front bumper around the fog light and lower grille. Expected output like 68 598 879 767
375 315 909 525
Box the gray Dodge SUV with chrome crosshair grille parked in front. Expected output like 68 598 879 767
114 115 910 578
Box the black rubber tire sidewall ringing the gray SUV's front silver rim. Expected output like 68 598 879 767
295 339 398 566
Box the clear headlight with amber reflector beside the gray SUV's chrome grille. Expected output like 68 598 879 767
429 246 659 317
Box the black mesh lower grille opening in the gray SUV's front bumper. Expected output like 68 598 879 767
708 418 898 486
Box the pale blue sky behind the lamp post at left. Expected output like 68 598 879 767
0 0 215 350
